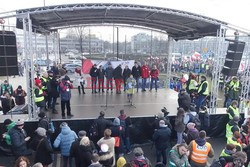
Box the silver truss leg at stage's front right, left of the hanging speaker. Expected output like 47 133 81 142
209 26 227 114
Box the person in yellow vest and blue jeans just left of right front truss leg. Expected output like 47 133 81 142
196 76 209 112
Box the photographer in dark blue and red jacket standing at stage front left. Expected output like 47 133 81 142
60 75 73 119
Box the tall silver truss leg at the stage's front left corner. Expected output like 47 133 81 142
22 14 37 120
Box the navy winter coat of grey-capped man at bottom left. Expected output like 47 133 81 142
9 126 31 156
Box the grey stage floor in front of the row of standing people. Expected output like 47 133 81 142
48 89 178 119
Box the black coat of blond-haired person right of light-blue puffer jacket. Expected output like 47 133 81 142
78 145 93 167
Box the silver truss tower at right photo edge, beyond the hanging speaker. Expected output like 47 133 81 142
239 37 250 113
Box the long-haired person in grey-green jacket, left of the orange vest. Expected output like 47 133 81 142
168 143 191 167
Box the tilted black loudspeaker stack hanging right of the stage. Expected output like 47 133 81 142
222 39 245 76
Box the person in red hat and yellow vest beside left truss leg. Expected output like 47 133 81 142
34 79 45 112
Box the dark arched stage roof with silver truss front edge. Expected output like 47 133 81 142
16 3 227 40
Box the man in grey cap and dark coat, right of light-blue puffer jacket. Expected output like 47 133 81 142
70 130 96 167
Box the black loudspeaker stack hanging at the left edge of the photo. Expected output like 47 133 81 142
0 31 18 76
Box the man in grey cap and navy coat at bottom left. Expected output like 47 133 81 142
9 119 31 159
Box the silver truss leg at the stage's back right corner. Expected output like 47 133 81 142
166 36 174 88
